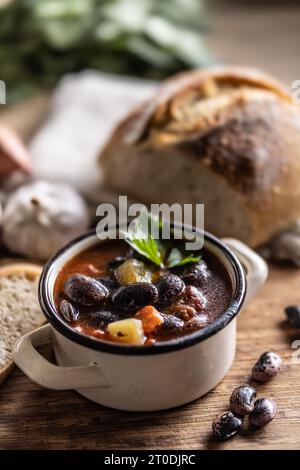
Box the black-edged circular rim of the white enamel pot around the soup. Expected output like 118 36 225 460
39 224 246 356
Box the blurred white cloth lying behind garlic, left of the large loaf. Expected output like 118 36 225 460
30 70 157 203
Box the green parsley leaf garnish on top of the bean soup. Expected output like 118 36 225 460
123 211 200 269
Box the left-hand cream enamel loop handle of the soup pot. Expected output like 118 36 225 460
13 323 109 390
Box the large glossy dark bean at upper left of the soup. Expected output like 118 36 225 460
64 274 109 307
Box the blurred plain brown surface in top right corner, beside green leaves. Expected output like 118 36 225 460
206 0 300 82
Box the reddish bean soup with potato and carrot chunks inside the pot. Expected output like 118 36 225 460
54 240 232 345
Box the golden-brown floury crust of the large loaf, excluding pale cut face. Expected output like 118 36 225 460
101 67 300 250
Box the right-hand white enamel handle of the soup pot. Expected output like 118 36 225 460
222 238 269 302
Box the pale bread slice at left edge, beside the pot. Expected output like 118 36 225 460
0 262 45 385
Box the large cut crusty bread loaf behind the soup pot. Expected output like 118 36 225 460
100 67 300 250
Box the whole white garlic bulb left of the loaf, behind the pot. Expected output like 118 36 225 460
2 181 89 260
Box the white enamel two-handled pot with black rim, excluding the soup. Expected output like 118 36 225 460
13 232 268 411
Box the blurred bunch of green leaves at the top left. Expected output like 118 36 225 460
0 0 212 102
